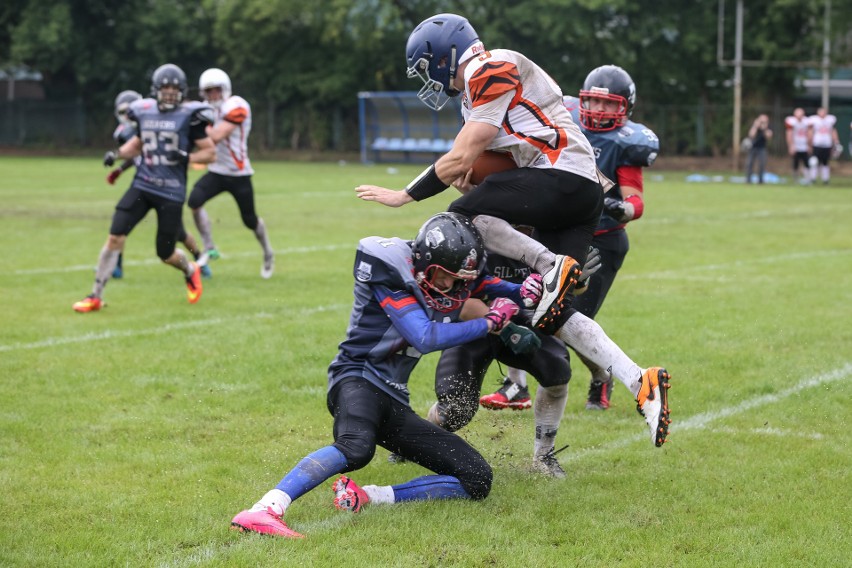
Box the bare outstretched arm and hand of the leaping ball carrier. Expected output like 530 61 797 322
355 122 498 207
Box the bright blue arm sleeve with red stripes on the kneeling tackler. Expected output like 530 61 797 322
372 285 488 353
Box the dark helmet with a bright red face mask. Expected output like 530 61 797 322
580 65 636 132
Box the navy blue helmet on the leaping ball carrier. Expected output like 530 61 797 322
405 14 485 110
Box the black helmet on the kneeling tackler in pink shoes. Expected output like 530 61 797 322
412 213 485 312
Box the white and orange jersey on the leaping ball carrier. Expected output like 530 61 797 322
462 49 611 189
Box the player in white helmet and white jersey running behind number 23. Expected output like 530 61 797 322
188 68 275 278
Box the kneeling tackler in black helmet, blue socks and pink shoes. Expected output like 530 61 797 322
231 213 540 538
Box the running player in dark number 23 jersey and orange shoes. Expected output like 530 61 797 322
73 63 216 312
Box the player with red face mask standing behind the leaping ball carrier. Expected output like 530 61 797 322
483 65 660 409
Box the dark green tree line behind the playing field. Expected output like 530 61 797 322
0 0 852 150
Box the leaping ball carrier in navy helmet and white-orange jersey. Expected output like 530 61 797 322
355 14 670 447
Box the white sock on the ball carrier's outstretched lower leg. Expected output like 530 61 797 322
556 312 642 398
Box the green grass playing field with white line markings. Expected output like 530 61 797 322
0 157 852 568
